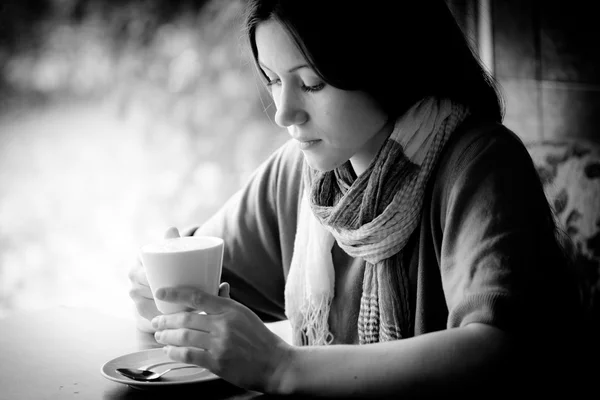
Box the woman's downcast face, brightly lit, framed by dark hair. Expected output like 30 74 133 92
256 21 393 175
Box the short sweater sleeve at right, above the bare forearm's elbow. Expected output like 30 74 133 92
440 124 568 331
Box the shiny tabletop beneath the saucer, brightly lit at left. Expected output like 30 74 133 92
0 306 290 400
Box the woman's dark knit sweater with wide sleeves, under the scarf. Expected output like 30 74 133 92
187 120 576 344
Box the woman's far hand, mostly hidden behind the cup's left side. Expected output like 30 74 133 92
129 227 179 332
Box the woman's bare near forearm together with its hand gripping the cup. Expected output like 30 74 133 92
152 288 515 398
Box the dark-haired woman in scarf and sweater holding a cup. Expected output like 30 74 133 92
130 0 577 397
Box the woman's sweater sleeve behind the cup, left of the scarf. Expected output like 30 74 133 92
186 142 303 322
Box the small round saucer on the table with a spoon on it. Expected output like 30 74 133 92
100 349 219 389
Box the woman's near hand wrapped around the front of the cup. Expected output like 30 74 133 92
152 283 292 393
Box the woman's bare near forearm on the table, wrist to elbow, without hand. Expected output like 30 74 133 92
280 324 510 397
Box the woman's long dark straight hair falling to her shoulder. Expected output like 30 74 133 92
245 0 504 122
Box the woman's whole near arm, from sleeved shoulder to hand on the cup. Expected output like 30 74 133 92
153 125 571 398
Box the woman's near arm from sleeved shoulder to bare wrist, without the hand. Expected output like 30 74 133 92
278 127 572 397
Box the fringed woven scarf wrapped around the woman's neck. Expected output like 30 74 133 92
285 98 468 345
